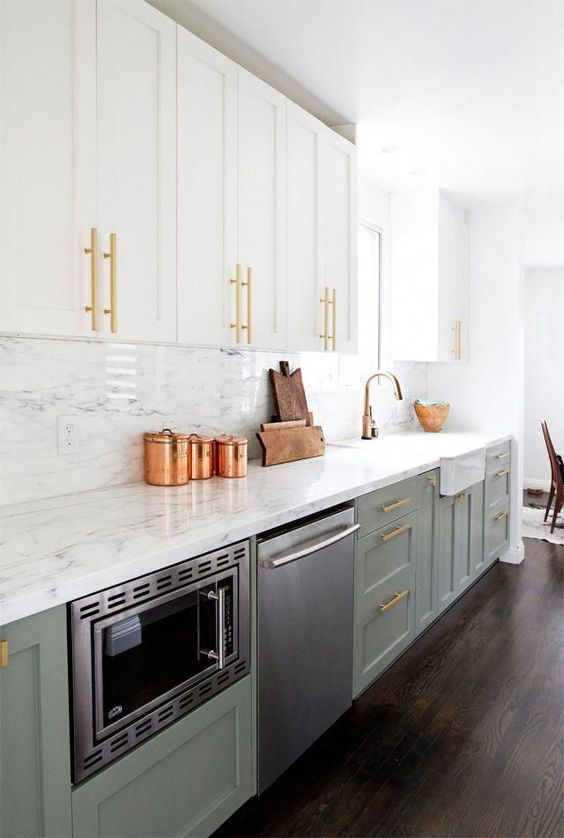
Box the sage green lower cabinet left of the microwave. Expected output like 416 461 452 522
0 606 72 838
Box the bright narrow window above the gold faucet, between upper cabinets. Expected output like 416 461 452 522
358 221 381 369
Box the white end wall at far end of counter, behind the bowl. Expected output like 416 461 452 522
428 207 525 561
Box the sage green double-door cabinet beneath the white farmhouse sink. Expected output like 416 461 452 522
438 481 485 612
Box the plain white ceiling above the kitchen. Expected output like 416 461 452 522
151 0 564 260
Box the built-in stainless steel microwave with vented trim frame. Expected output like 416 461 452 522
69 542 250 782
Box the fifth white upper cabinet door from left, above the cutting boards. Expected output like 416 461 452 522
286 101 326 352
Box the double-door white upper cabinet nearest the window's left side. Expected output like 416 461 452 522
287 102 357 352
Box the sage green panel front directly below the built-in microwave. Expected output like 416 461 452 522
72 677 254 838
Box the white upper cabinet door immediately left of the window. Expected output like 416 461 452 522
323 130 358 353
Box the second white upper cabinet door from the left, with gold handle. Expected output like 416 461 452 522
96 0 176 341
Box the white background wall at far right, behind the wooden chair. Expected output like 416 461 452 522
525 268 564 489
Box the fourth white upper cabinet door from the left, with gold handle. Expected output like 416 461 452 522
237 68 286 349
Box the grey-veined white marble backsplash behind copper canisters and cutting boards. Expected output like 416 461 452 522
0 337 427 505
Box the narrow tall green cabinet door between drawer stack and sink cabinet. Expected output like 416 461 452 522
415 469 439 634
